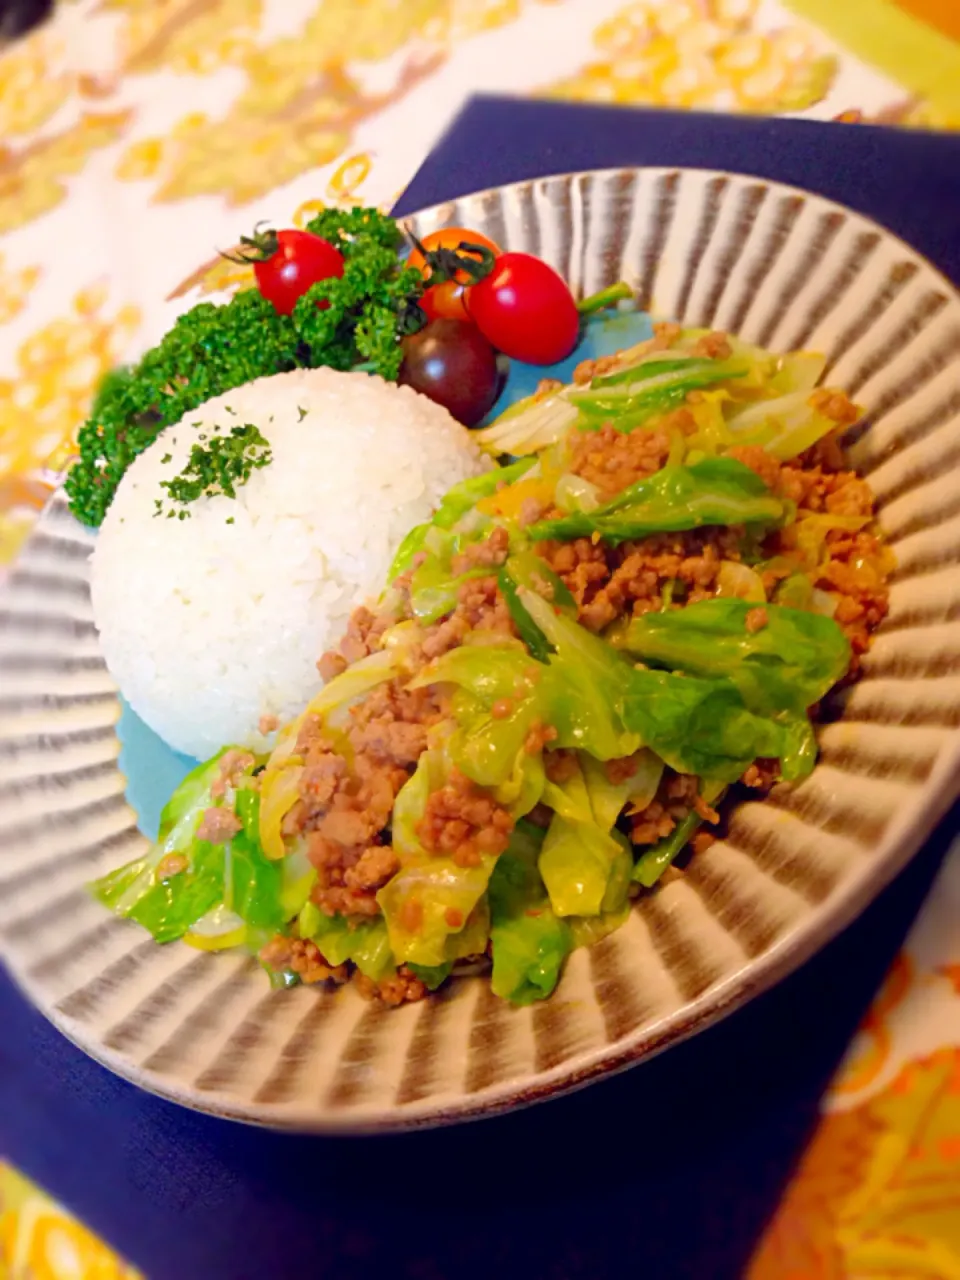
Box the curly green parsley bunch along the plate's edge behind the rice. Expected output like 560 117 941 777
65 209 425 525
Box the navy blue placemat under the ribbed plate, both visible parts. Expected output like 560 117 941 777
0 100 960 1280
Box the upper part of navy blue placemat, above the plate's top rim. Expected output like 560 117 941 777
396 97 960 280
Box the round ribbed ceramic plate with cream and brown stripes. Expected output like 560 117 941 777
0 169 960 1130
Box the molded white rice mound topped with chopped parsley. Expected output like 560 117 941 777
91 369 490 759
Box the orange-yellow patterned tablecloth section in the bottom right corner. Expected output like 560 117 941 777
748 844 960 1280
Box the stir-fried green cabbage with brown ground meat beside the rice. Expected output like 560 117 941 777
95 312 892 1005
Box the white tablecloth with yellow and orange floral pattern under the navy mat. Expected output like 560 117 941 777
0 0 960 1280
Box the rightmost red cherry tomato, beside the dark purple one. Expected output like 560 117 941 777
466 253 580 365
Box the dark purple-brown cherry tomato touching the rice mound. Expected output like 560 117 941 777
398 320 503 426
